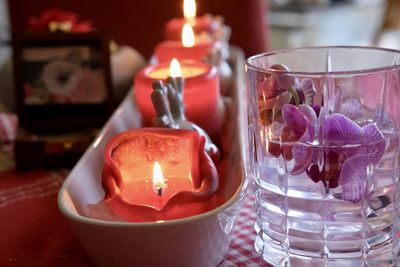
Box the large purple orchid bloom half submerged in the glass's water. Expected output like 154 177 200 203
282 104 385 203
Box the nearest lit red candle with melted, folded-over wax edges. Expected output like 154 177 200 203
102 128 218 221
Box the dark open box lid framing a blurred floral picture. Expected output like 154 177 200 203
13 31 112 133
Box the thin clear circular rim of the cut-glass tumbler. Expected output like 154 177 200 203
245 45 400 76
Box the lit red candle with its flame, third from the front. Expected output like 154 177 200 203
154 23 222 62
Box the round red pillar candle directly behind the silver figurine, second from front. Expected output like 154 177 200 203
134 60 223 143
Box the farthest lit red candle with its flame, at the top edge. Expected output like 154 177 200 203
164 0 219 40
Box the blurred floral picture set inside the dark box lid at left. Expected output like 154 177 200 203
22 46 107 105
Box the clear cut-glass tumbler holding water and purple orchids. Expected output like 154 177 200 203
246 46 400 267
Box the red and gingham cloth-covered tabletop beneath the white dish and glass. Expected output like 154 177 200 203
0 169 268 267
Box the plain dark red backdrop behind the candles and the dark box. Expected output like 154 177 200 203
8 0 268 57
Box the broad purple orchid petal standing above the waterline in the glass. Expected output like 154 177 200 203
324 113 363 145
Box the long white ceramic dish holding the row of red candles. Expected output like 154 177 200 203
58 47 247 267
